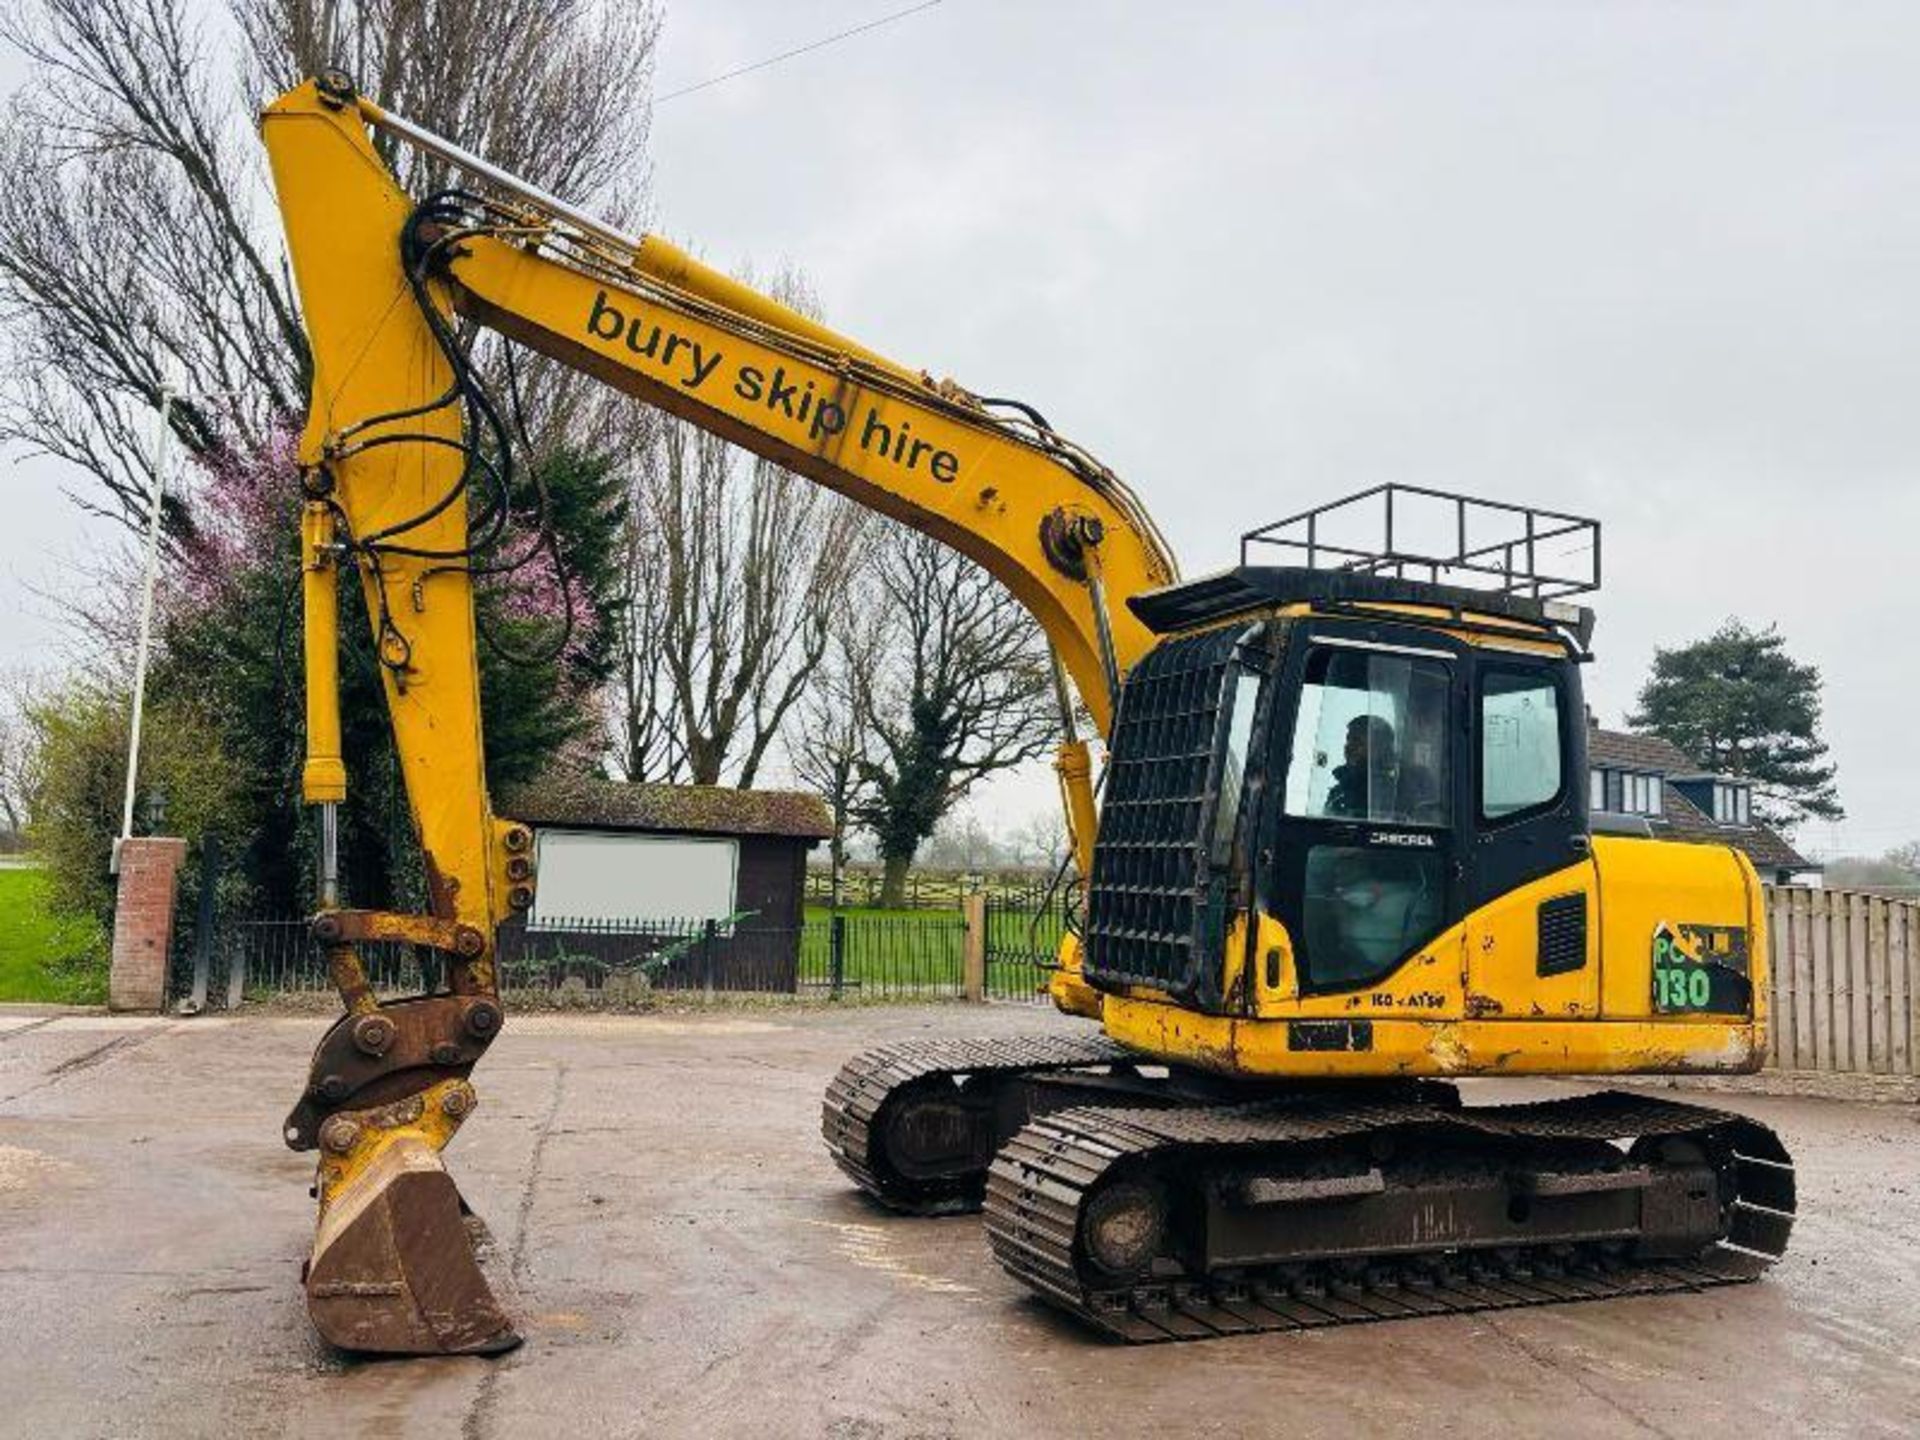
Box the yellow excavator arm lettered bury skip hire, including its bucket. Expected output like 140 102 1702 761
263 75 1179 1354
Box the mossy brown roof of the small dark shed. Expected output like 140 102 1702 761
497 772 833 841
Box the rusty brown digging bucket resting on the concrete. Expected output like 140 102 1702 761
307 1139 520 1356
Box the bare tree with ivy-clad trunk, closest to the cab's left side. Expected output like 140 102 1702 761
858 530 1058 904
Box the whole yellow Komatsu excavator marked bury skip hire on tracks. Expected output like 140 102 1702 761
263 73 1795 1354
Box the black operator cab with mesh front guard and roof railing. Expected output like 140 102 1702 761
1085 488 1597 1012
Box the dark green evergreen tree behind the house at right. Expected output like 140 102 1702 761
1628 620 1845 826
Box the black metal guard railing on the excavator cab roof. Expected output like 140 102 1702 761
1240 484 1599 599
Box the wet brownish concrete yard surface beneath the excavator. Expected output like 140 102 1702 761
0 1004 1920 1440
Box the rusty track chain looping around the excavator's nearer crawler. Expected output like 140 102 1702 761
985 1091 1793 1342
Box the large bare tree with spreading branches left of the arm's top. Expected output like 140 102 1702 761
0 0 295 522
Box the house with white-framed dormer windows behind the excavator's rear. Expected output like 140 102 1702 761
1586 716 1820 885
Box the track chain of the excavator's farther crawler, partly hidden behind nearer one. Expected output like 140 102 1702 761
820 1035 1140 1215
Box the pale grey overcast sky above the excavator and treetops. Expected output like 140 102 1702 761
0 0 1920 852
